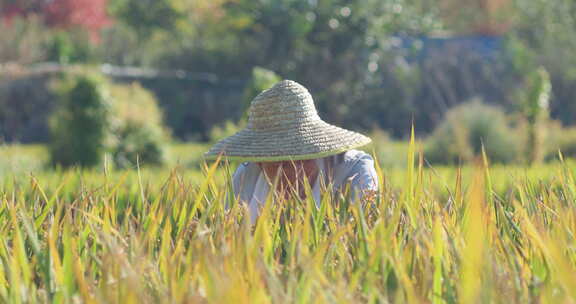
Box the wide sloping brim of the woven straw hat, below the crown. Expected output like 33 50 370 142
204 120 371 162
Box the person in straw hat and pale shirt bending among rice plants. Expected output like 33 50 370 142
206 80 378 222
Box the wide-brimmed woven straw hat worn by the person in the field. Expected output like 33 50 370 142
205 80 371 162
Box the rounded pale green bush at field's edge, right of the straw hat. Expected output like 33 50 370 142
425 100 521 164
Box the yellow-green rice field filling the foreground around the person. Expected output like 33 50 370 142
0 143 576 303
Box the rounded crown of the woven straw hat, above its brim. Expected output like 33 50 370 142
247 80 320 131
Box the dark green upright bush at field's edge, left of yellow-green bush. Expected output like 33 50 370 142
49 74 110 167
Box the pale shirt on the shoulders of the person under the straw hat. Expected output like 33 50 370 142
232 150 378 223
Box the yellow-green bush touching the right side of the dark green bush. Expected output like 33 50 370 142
111 83 169 168
